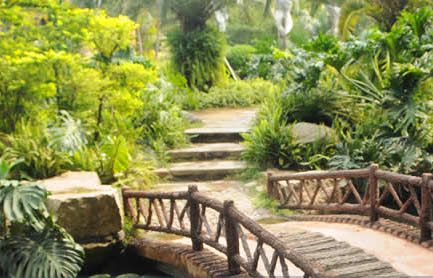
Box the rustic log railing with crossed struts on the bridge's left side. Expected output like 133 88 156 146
122 186 320 277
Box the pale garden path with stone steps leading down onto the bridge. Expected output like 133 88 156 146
149 108 433 276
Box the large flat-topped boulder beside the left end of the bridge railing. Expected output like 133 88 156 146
40 172 122 243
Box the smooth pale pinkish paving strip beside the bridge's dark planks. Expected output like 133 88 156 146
264 221 433 276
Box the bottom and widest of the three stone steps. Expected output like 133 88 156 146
154 160 247 181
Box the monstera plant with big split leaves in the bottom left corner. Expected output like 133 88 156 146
0 180 84 278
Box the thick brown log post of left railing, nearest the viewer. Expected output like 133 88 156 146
224 201 241 275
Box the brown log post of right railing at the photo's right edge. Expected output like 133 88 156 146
419 173 432 242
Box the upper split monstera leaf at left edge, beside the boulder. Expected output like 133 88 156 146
0 180 48 225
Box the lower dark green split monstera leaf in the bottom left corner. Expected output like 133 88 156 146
0 229 84 278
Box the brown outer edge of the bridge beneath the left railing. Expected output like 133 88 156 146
129 238 247 278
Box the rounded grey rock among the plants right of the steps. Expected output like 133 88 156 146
292 122 335 144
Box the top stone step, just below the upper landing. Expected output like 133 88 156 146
185 127 249 143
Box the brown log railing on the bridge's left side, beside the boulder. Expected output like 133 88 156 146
122 186 320 277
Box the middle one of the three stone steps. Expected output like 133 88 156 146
168 143 245 161
